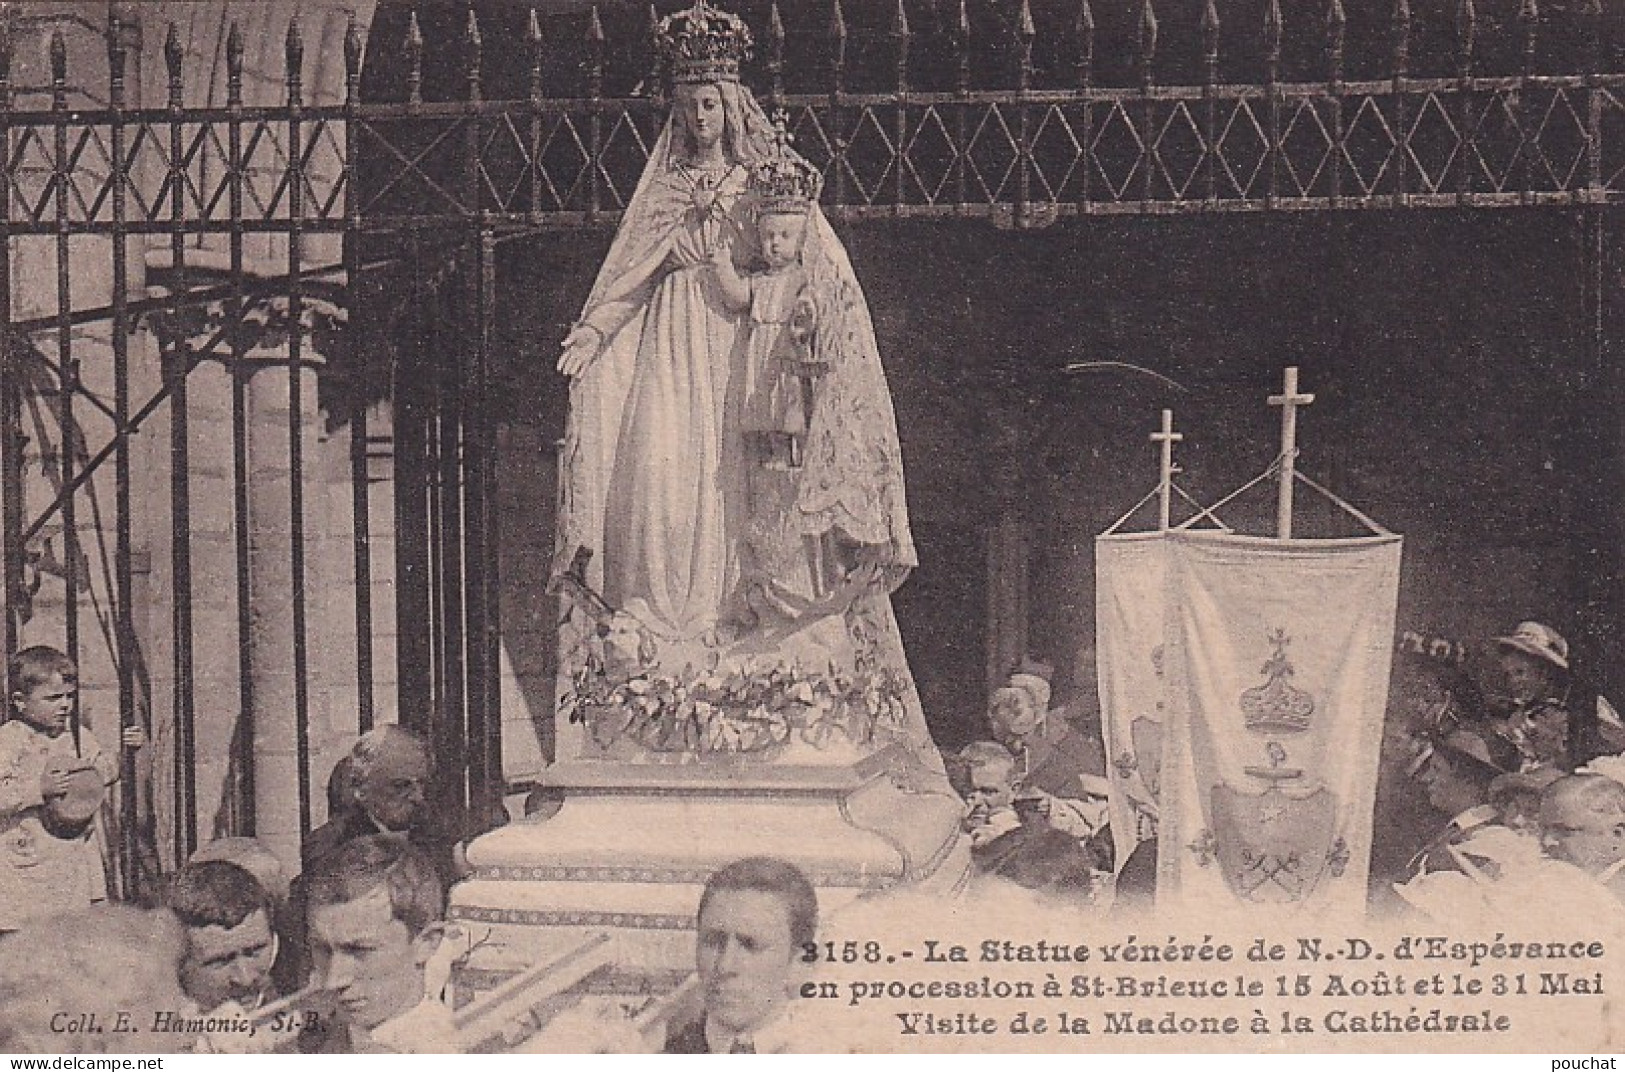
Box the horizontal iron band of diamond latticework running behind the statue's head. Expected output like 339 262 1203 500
0 0 1625 236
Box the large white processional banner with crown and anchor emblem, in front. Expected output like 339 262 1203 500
1157 531 1401 919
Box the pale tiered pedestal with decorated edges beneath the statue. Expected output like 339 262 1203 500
450 746 970 979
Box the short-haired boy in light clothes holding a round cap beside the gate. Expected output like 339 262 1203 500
0 645 146 932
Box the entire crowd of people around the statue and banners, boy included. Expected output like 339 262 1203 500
0 622 1625 1053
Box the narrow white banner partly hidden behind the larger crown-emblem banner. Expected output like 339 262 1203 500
1095 533 1168 867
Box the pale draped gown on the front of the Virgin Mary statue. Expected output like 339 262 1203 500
572 164 744 637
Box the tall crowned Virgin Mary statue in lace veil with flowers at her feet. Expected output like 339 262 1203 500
556 0 930 769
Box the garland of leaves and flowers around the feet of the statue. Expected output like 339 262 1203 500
559 639 907 765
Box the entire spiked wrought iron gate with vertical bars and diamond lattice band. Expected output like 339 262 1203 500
0 0 1625 885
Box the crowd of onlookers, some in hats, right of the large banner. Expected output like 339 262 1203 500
1370 622 1625 921
